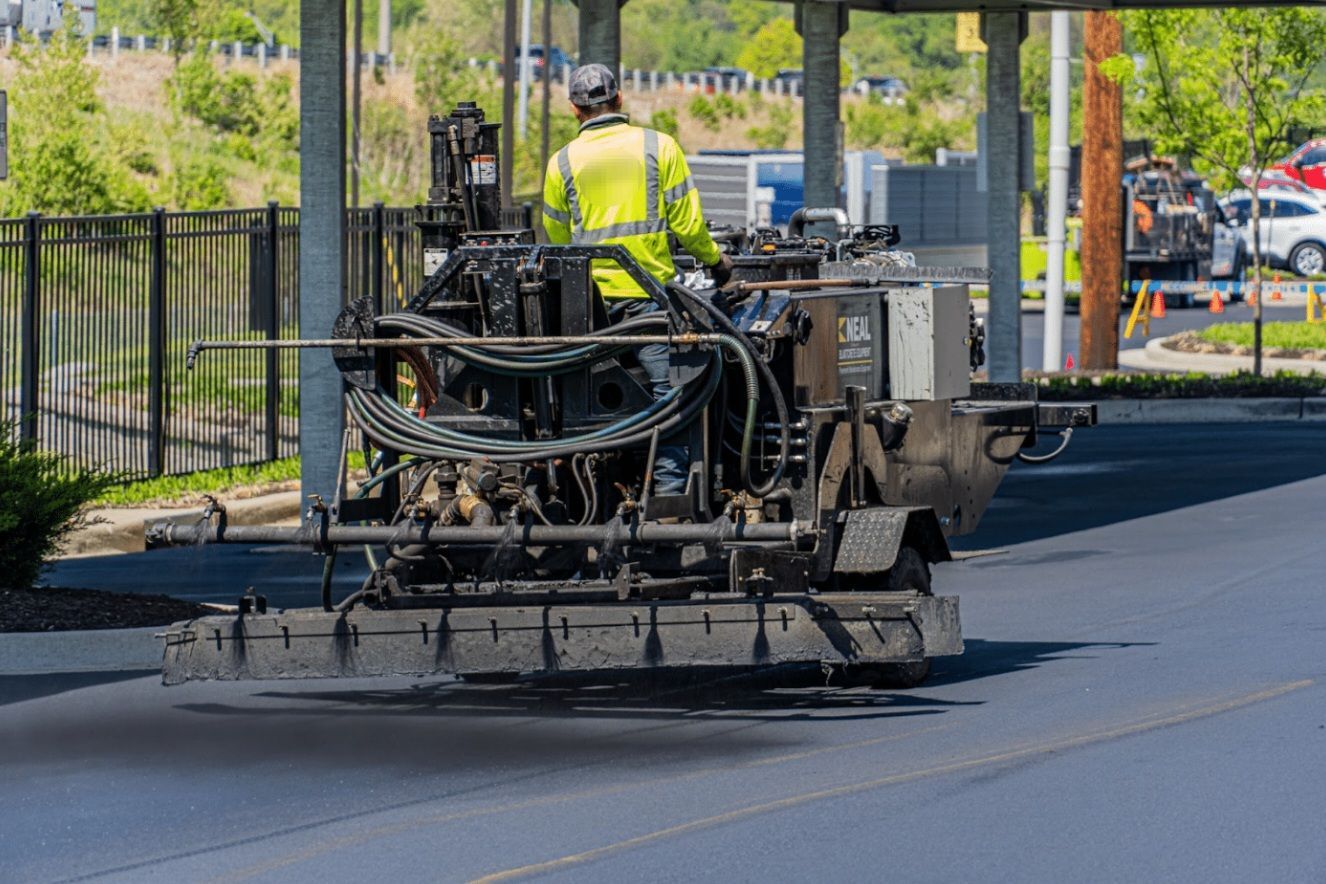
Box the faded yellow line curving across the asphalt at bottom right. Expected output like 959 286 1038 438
473 679 1313 884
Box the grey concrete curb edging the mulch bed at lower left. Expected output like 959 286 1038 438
0 627 164 676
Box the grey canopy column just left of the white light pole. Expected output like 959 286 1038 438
981 12 1025 383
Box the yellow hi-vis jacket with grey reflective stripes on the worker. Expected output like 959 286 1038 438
544 114 719 300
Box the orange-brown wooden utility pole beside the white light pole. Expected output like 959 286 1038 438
1082 12 1123 370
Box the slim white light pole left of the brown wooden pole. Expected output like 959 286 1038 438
1041 12 1071 371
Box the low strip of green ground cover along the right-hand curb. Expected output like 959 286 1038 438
1036 371 1326 402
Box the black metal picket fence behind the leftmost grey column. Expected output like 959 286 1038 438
0 203 423 476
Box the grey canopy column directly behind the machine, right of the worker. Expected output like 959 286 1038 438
796 0 847 235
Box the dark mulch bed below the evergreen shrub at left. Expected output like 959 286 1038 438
0 587 216 632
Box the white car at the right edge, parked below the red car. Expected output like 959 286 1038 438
1220 191 1326 276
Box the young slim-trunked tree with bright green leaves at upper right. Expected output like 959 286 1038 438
1103 7 1326 374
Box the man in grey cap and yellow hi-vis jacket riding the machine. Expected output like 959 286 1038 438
544 64 732 494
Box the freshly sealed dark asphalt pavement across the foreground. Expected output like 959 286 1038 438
15 425 1326 883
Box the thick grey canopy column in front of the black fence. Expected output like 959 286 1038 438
300 0 346 502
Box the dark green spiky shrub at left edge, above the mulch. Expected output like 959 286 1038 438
0 420 121 590
